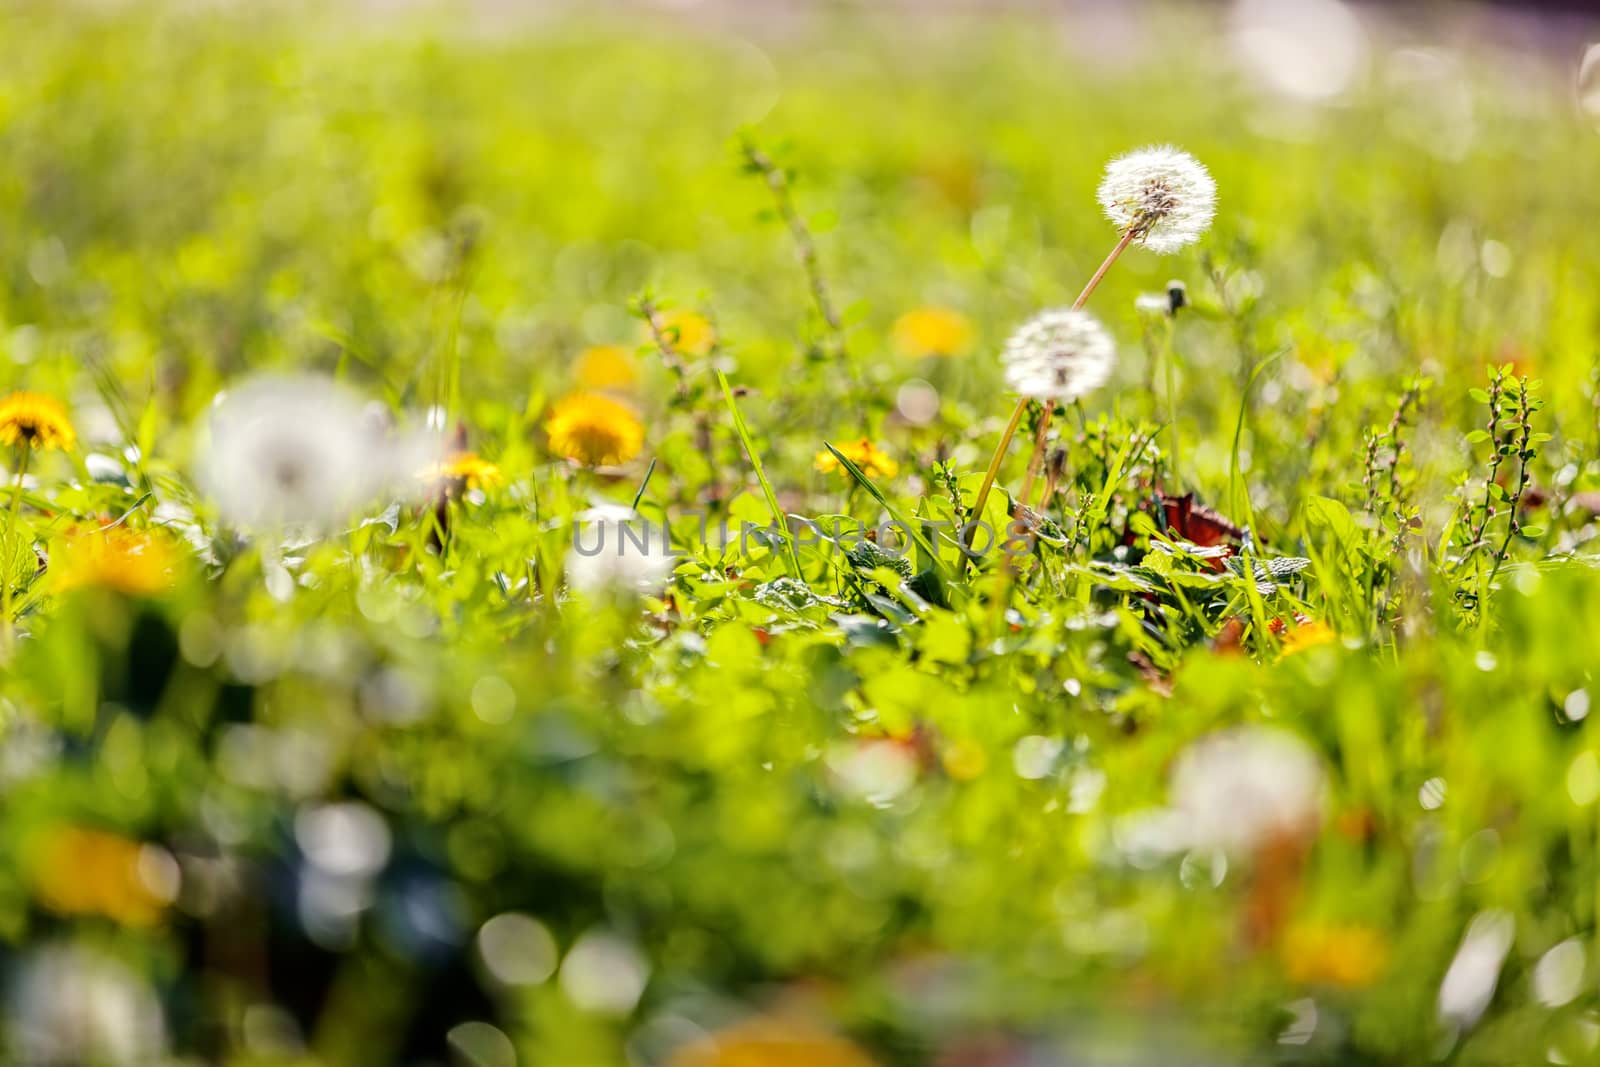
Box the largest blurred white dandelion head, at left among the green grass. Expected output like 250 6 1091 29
198 374 440 530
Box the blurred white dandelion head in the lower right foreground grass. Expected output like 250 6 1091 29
1171 726 1323 856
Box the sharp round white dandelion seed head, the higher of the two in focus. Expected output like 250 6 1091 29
1099 144 1216 253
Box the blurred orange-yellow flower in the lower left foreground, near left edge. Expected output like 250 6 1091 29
30 825 176 926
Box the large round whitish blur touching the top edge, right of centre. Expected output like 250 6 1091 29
1229 0 1366 101
